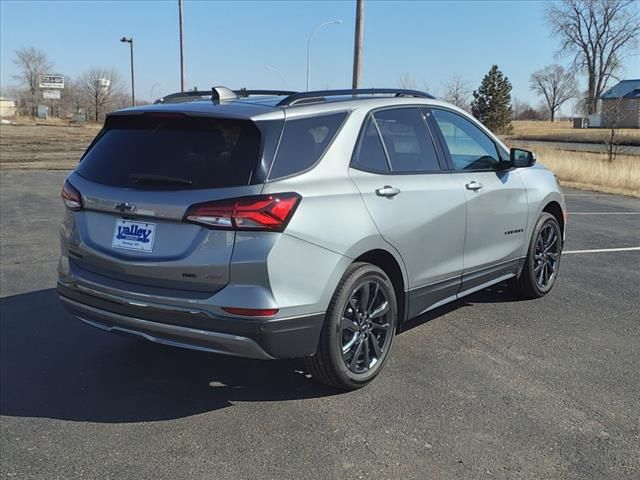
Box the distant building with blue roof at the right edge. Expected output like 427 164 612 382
600 78 640 128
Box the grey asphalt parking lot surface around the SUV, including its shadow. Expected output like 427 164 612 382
0 171 640 480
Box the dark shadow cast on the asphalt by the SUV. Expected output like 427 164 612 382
0 287 514 423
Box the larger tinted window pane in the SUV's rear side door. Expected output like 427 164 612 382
374 108 440 172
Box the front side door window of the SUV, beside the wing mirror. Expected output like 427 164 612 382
432 109 500 170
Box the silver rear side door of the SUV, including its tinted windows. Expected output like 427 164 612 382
350 107 465 316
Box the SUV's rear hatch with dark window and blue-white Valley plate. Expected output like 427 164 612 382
69 112 277 294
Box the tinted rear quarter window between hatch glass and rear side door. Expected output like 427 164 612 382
269 112 347 179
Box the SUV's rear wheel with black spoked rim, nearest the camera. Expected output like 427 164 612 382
305 263 398 390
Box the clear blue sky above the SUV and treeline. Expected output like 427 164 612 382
0 0 640 113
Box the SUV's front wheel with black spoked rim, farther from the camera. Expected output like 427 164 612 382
511 212 562 299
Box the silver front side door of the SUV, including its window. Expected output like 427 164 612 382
431 108 528 291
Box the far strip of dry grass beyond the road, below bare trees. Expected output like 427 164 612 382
504 120 640 146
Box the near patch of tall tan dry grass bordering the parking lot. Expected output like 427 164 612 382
536 148 640 198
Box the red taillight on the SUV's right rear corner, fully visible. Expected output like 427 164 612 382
184 193 302 232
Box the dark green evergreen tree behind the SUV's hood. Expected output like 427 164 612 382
471 65 511 133
